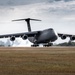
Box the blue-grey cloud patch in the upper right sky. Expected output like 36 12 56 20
39 0 75 16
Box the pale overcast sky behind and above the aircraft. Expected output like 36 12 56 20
0 0 75 46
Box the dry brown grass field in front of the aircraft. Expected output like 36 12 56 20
0 47 75 75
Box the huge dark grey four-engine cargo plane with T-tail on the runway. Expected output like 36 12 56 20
0 18 75 47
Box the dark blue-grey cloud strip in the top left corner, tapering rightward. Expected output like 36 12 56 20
0 0 45 6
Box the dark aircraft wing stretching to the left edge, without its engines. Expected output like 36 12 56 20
0 31 39 38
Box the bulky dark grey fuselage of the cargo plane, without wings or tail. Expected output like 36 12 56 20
28 28 57 44
